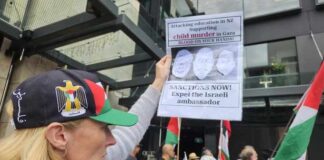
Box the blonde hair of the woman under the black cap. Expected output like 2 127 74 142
0 101 82 160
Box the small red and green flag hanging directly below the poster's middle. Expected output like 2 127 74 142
165 117 179 146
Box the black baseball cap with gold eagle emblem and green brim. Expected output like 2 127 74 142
11 69 138 129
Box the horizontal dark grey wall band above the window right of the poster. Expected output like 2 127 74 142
244 0 324 45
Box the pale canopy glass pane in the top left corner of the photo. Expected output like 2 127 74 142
0 0 87 30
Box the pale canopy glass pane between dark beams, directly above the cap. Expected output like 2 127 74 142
56 31 145 65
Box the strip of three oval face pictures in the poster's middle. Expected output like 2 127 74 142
169 45 238 81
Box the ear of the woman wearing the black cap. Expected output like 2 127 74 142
45 122 68 150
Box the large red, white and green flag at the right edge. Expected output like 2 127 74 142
275 63 324 160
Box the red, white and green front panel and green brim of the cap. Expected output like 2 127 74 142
85 80 138 126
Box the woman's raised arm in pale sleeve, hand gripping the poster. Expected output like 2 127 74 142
106 55 171 160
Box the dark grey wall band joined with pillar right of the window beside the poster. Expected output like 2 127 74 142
244 0 324 89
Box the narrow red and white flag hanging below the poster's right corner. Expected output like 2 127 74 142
218 121 232 160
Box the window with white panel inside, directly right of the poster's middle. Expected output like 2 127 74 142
244 40 299 88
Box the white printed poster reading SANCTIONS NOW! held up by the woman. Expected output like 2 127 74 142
158 12 243 120
